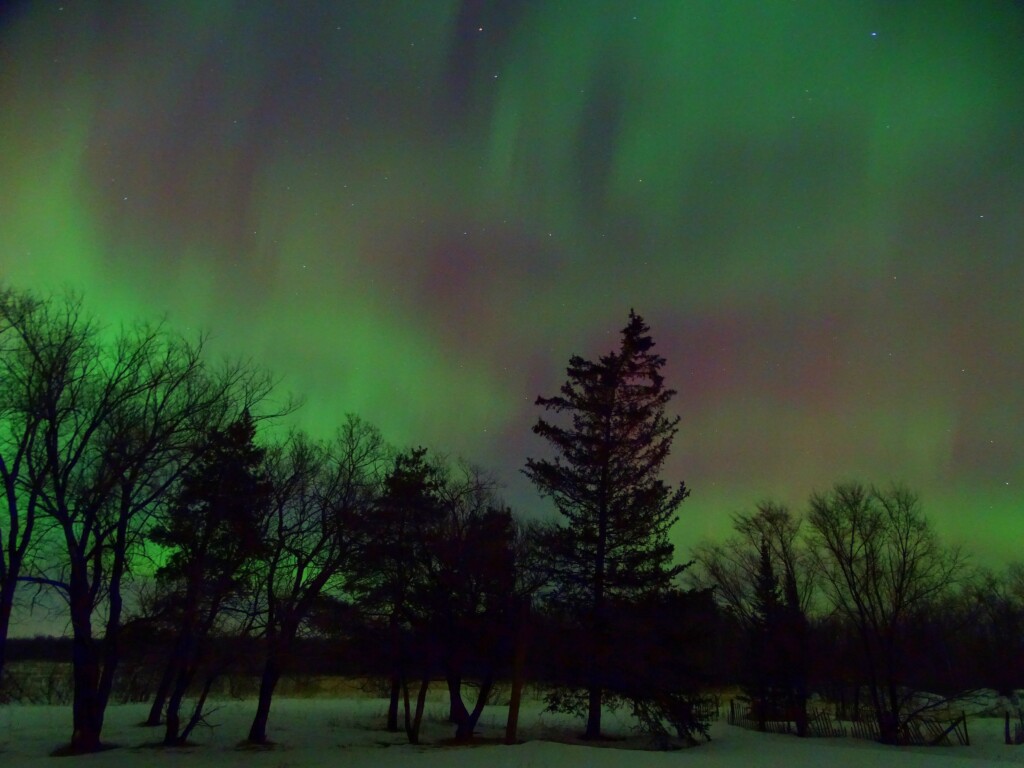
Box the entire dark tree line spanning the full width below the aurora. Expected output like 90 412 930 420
0 290 1011 752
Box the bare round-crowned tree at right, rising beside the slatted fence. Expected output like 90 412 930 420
808 483 963 743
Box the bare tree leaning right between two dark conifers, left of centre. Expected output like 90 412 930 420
249 416 387 743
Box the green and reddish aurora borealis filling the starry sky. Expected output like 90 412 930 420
0 0 1024 560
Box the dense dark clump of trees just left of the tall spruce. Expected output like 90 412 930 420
351 449 516 742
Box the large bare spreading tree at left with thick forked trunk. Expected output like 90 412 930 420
5 288 270 752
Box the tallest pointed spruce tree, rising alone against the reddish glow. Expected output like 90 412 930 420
524 310 689 738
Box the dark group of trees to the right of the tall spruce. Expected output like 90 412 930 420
696 482 1024 743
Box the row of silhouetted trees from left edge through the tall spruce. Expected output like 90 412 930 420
0 291 720 752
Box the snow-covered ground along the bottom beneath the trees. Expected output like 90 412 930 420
0 695 1024 768
